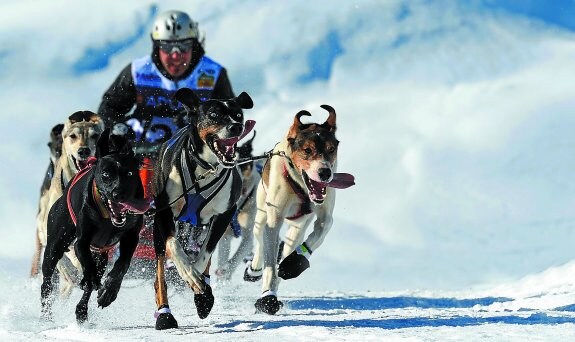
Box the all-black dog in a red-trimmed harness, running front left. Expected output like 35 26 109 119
41 130 150 323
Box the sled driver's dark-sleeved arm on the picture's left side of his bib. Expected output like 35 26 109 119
98 64 136 127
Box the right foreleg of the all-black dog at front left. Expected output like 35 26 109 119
98 226 142 308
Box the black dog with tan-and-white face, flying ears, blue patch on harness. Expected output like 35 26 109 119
154 88 255 330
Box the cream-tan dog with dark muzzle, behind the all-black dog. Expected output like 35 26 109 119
31 111 104 295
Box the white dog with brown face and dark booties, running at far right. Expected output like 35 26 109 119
244 105 355 315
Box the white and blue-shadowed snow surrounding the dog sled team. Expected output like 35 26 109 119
0 0 575 341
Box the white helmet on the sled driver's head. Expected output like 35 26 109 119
151 11 199 41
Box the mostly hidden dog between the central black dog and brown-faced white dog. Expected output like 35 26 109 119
216 131 262 281
